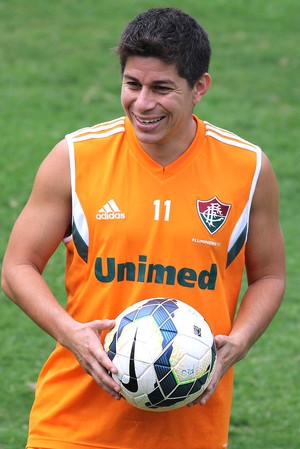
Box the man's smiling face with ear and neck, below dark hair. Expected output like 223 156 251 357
121 56 206 158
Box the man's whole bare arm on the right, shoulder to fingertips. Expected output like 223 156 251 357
196 155 285 405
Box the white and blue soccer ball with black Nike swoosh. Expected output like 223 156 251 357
104 298 216 411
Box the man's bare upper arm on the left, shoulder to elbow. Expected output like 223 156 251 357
5 140 72 272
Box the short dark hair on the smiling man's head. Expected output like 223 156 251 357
116 8 211 87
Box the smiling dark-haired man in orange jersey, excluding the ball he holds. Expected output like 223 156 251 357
2 8 285 449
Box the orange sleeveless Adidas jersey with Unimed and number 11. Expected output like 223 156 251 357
28 117 260 449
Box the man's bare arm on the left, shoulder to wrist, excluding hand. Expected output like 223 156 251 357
2 143 71 341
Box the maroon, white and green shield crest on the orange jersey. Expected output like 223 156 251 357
197 196 231 235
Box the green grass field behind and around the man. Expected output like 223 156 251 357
0 0 300 449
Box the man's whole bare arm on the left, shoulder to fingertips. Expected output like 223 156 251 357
2 141 118 397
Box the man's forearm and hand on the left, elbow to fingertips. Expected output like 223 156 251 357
2 265 120 400
